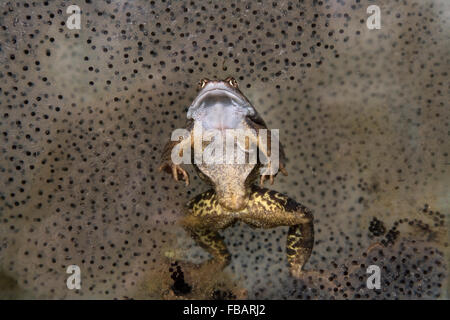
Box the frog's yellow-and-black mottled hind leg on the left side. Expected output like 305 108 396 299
181 190 236 268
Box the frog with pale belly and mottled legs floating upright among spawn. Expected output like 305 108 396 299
159 77 314 277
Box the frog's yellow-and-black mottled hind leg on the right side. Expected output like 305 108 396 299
240 186 314 277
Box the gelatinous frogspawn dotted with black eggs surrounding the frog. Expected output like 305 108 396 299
0 0 450 299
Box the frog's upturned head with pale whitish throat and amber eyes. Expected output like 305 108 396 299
187 77 256 129
